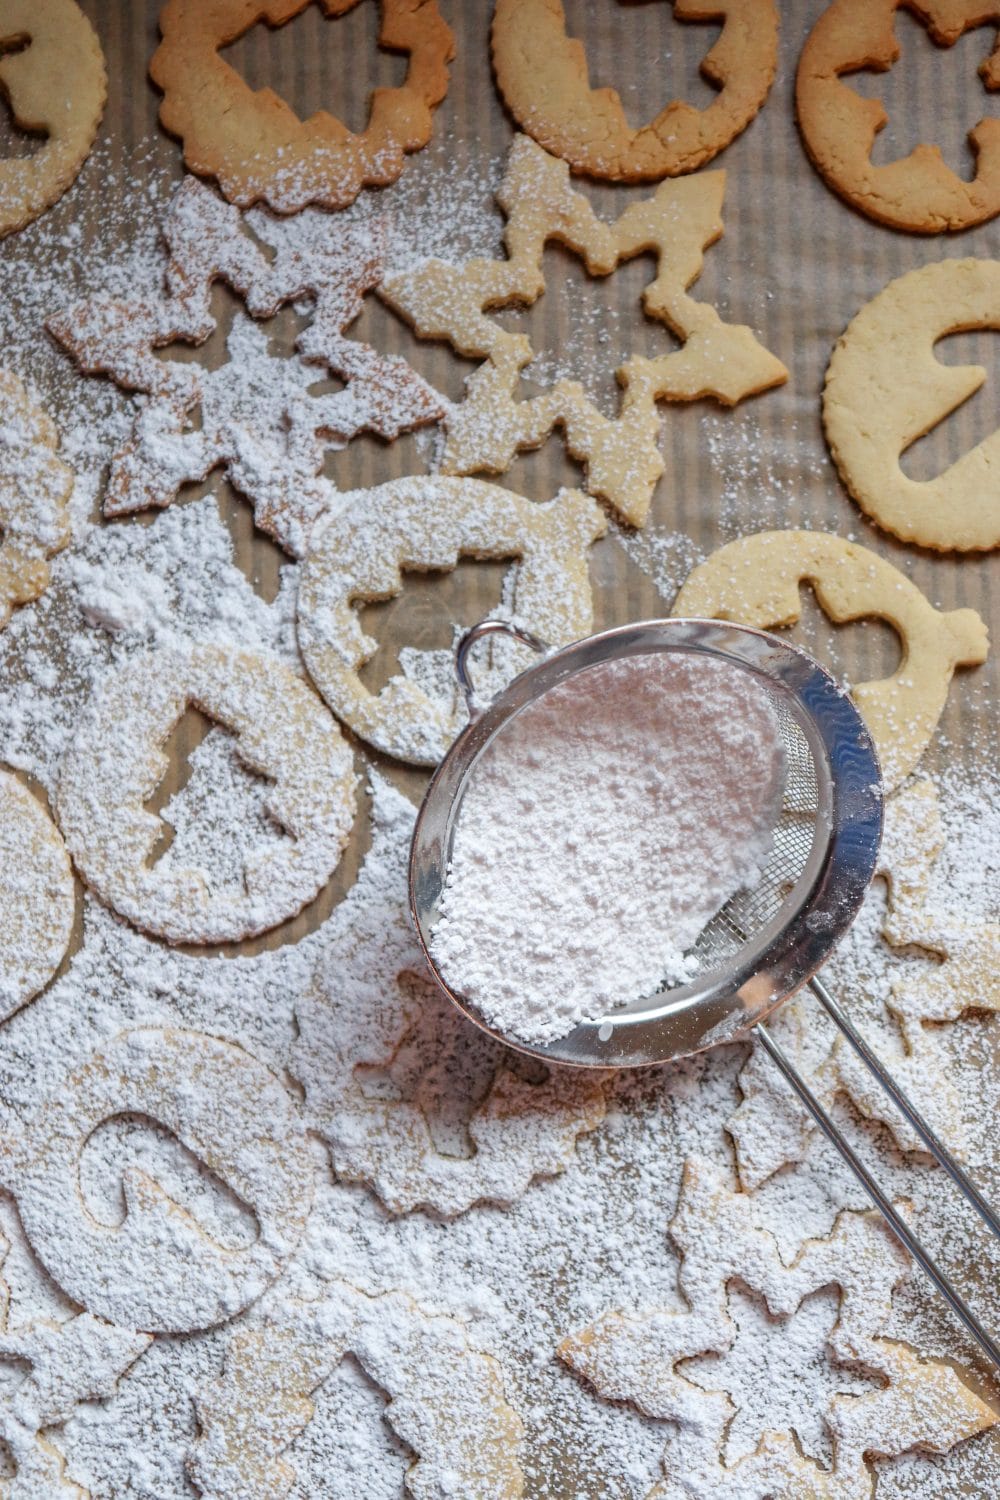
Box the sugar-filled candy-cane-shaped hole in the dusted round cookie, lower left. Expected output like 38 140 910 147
79 1113 261 1250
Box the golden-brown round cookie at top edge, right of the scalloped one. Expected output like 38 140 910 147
492 0 778 182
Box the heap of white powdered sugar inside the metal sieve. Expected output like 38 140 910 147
432 653 786 1043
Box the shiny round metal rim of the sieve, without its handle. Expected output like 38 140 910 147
409 620 883 1068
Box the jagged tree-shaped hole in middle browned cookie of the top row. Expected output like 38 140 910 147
562 0 723 122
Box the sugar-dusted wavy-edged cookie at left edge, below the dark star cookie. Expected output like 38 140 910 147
0 369 73 630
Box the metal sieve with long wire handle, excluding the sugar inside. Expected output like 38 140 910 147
409 620 1000 1367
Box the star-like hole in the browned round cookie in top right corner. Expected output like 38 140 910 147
841 9 996 182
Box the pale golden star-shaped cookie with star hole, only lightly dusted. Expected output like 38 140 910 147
379 135 789 527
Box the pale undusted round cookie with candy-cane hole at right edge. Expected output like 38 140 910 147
823 261 1000 552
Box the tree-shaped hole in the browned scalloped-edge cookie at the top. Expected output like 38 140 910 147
219 0 406 135
